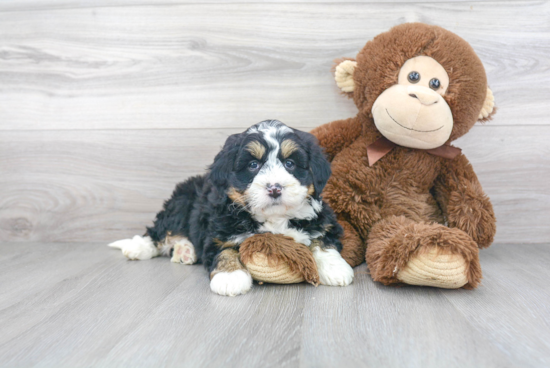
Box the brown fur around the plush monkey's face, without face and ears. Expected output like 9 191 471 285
353 23 494 141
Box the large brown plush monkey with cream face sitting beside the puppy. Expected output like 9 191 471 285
312 23 496 288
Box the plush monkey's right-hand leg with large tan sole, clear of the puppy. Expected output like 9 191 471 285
366 216 481 289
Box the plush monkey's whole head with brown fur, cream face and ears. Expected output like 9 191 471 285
334 23 495 145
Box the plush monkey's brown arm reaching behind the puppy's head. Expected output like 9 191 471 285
311 118 362 161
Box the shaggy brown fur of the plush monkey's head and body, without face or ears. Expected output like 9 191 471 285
312 23 496 287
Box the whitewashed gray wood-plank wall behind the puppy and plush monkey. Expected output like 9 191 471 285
0 0 550 243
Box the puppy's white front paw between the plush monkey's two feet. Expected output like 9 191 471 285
313 247 353 286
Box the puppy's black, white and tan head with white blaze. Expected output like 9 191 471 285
210 120 331 219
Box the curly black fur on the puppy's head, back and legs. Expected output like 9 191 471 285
147 121 343 272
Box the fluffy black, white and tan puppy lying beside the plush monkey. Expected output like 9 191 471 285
109 120 353 296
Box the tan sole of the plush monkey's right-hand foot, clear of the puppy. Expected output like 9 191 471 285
397 248 468 289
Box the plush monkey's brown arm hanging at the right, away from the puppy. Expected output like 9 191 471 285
434 154 496 248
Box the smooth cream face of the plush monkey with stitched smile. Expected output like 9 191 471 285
372 56 453 149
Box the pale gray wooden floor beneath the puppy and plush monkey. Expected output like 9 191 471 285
0 243 550 368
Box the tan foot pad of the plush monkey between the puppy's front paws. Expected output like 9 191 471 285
246 253 305 284
